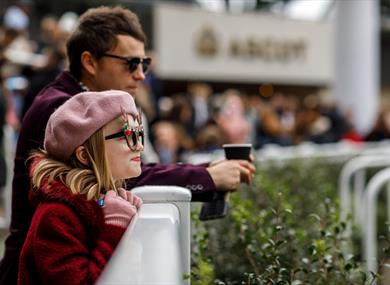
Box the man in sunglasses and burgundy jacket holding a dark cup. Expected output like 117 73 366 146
0 7 255 285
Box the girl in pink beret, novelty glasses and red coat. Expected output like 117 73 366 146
18 90 144 285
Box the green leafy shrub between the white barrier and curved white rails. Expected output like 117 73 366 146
192 161 386 285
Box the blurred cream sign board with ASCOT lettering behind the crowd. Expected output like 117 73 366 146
154 5 333 85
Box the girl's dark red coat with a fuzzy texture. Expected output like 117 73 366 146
18 178 125 285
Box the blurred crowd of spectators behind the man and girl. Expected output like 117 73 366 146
0 1 390 169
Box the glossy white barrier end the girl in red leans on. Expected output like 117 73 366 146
97 186 191 285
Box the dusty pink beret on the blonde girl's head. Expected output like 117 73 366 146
44 90 138 160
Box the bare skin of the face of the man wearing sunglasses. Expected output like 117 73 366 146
93 35 145 96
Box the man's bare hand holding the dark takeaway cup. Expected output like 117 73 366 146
206 157 256 191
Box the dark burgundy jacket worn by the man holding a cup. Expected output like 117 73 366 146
0 71 215 285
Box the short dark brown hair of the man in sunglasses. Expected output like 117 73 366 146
66 6 146 79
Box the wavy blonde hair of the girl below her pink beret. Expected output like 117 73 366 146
28 128 123 200
